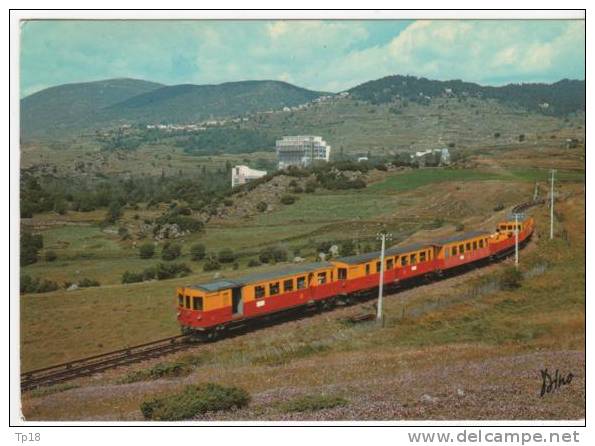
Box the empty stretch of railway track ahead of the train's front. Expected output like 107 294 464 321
21 335 192 391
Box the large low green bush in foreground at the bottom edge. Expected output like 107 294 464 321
140 383 250 421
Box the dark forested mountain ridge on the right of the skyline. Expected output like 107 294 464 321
348 75 585 116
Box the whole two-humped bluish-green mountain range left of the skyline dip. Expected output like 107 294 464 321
21 79 324 137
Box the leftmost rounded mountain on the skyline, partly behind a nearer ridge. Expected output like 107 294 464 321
21 79 163 135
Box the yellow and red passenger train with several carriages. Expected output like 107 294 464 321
177 217 534 339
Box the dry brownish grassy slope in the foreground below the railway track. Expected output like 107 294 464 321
24 180 585 420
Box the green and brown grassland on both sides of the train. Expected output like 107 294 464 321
20 144 585 419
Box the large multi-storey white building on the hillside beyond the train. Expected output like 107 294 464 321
276 135 331 169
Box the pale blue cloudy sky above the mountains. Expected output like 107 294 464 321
21 20 585 96
